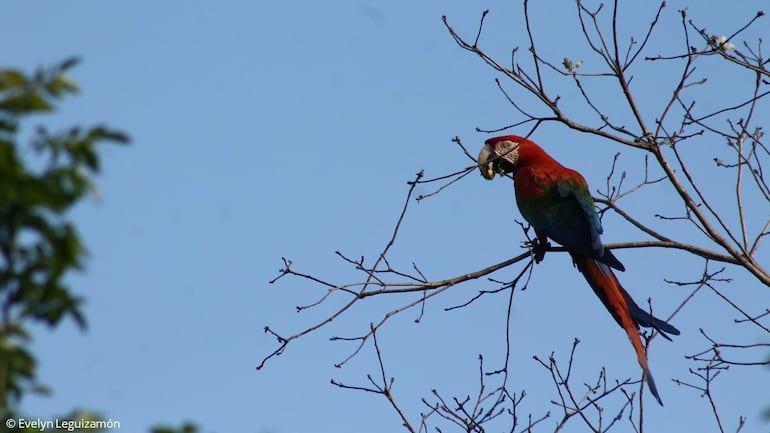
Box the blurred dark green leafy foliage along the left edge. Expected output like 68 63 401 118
0 59 128 412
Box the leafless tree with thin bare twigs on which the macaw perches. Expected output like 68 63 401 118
257 0 770 432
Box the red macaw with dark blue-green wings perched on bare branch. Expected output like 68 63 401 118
478 135 679 406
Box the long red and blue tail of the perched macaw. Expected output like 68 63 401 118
572 254 668 406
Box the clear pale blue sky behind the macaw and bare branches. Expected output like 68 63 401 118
0 1 770 433
